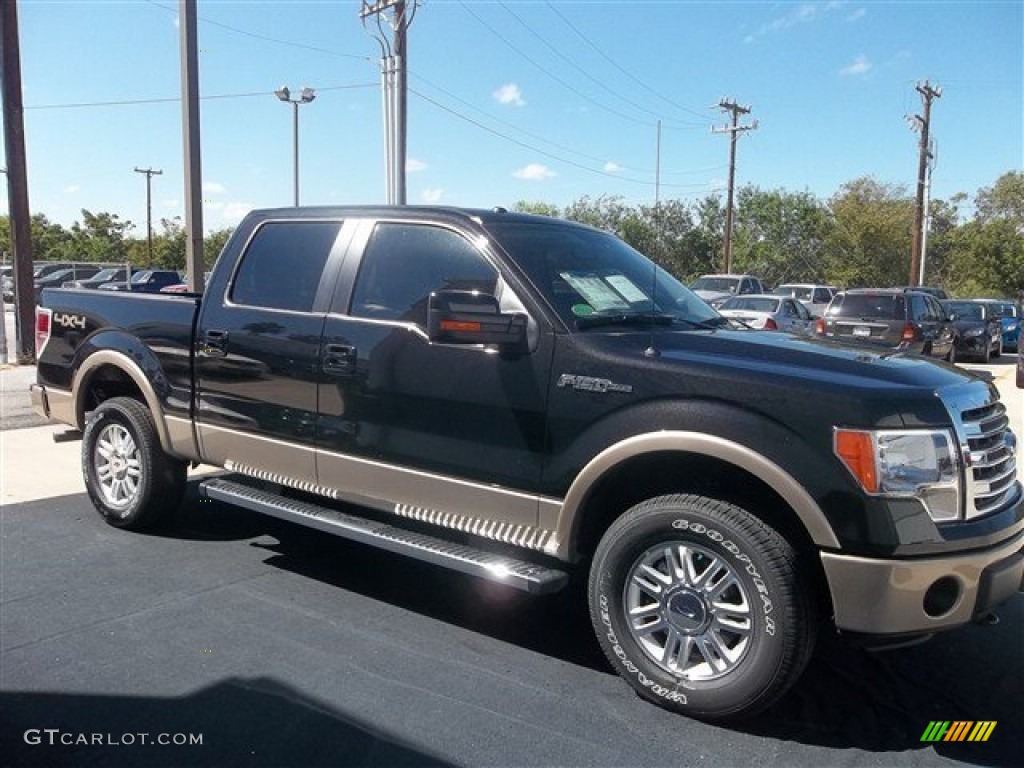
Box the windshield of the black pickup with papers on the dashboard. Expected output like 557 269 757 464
487 221 723 327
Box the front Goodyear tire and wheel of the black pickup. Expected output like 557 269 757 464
589 496 816 720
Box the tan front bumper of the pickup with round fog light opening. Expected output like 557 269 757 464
821 532 1024 635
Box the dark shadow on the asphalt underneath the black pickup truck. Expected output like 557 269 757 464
155 481 1024 765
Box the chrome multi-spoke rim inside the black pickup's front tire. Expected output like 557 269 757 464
623 542 754 680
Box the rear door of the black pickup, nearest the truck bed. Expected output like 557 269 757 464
196 219 345 484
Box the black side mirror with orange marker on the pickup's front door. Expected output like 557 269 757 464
427 289 526 346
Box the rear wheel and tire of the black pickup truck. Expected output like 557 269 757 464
82 397 185 530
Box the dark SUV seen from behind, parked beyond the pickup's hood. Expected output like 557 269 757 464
814 288 956 362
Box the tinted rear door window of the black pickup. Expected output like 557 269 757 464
231 221 341 312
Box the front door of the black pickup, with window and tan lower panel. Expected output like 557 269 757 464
317 219 553 525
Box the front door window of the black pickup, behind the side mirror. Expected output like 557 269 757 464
350 223 498 326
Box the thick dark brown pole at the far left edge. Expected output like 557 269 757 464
0 0 36 365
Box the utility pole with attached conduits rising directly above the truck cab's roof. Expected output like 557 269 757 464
359 0 419 206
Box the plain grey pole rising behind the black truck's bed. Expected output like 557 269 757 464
178 0 205 293
